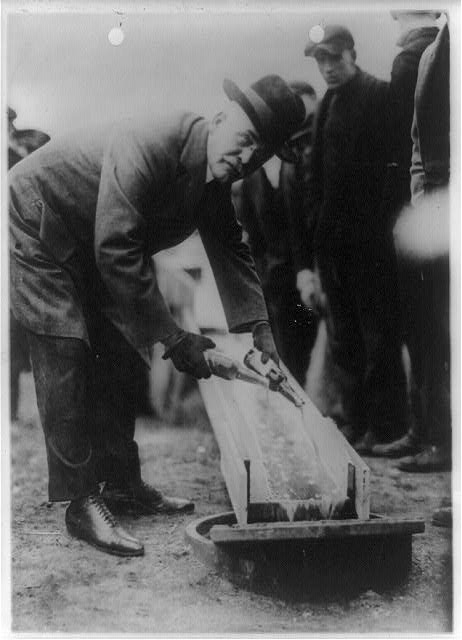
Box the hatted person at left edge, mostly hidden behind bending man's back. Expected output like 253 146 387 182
8 107 50 420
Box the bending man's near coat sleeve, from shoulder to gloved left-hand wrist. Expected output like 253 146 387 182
95 125 178 347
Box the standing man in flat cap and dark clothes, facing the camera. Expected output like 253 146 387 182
299 25 408 453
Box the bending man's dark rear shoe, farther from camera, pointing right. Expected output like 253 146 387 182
102 481 194 515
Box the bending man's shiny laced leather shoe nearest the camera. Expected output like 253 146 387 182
66 494 144 557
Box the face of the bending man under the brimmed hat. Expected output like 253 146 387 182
207 102 272 183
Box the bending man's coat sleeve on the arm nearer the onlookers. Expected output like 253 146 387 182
199 180 268 333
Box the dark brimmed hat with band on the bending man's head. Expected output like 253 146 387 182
223 75 305 162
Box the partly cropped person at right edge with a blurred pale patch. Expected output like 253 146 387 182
388 24 451 472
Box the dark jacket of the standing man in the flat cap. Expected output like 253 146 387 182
305 69 388 256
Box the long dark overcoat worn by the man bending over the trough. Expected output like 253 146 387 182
9 112 267 361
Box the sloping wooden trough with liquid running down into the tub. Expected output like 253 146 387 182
193 334 370 526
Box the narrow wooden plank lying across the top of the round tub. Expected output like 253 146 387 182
210 518 425 544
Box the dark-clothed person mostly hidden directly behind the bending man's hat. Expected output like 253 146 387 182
233 82 317 385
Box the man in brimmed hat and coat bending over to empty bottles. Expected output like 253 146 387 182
9 76 305 556
